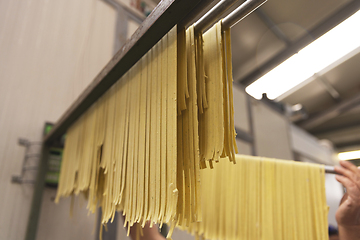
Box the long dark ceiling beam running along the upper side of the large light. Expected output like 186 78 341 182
237 0 360 86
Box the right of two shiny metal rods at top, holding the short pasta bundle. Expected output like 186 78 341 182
222 0 267 28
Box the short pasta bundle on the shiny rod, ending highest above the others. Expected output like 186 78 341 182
197 21 237 168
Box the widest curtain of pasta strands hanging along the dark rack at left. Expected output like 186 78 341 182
56 27 178 232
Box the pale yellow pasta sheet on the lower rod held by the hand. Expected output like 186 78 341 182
186 155 328 240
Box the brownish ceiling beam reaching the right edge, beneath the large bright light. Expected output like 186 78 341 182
299 93 360 130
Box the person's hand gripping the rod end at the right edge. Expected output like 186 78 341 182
335 161 360 240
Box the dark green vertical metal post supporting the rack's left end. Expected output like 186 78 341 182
25 142 50 240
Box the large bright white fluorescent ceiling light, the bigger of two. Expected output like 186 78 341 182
246 11 360 99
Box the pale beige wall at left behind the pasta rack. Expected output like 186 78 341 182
0 0 116 240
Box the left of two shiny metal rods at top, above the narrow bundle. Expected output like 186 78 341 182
194 0 237 33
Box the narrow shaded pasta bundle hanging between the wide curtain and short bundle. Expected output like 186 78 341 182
177 26 201 226
